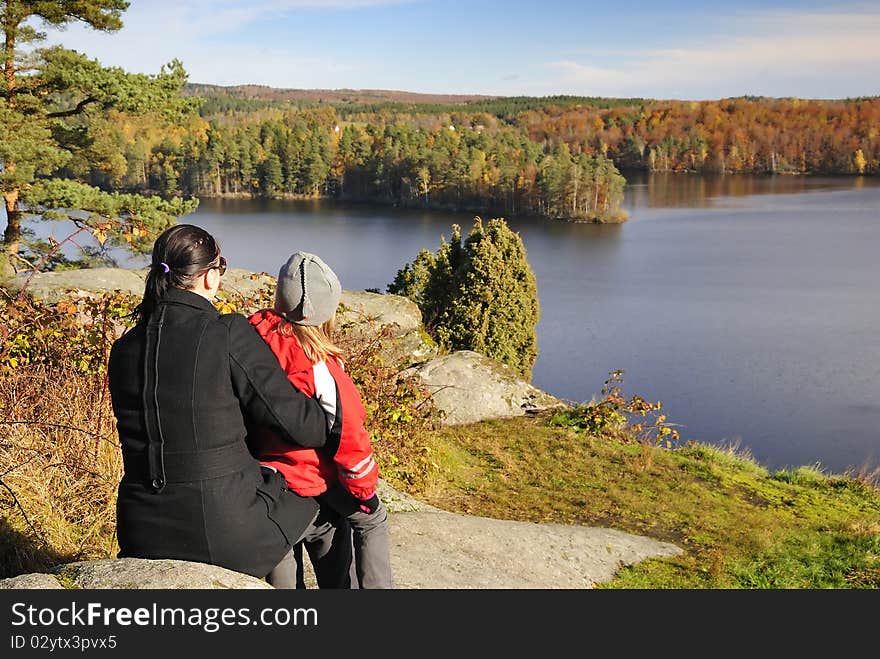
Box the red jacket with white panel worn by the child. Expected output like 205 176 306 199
248 309 379 500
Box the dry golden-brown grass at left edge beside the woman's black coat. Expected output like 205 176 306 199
0 367 123 577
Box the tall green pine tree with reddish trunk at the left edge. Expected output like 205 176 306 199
0 0 197 274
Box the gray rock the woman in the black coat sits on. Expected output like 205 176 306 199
56 558 272 590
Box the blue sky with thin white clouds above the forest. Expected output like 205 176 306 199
37 0 880 100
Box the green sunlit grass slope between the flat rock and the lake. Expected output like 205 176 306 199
422 417 880 588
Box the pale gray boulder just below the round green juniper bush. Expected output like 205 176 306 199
402 350 564 425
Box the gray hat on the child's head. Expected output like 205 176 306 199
275 252 342 327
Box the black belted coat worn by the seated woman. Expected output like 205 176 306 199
109 289 327 577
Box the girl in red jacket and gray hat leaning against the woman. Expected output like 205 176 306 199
249 252 392 588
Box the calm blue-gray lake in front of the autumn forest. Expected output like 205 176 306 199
20 174 880 472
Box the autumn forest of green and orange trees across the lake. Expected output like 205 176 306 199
58 90 880 221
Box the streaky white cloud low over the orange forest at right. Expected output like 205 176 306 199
532 11 880 98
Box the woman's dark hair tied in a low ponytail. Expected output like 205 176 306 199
134 224 220 322
